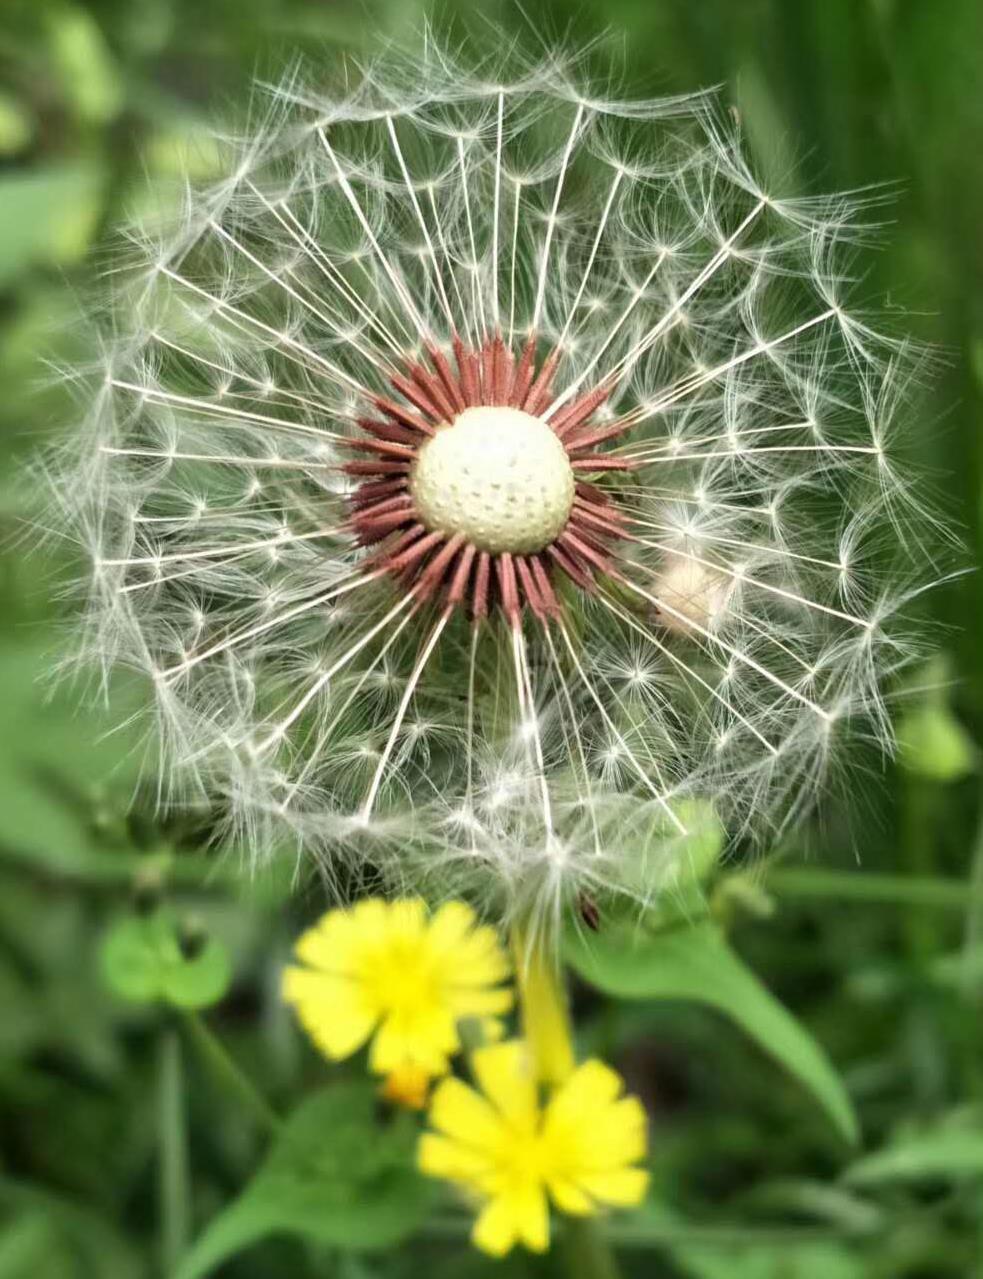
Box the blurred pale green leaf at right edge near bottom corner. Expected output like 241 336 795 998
844 1113 983 1186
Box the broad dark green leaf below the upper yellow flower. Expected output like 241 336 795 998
174 1082 431 1279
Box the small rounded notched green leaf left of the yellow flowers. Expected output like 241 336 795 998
100 911 231 1008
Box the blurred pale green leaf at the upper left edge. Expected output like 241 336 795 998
0 161 102 288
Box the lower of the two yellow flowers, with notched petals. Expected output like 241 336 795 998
418 1041 648 1256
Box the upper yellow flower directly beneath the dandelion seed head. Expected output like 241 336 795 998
284 898 513 1088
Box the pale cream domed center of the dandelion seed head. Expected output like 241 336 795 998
409 405 574 555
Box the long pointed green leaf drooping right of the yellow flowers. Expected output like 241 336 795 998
565 922 859 1143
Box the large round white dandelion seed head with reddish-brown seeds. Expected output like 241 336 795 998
61 45 930 908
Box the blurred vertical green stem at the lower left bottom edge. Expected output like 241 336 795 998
157 1027 190 1279
